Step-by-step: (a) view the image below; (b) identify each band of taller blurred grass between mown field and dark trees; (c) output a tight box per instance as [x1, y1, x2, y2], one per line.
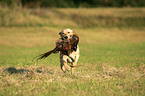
[0, 8, 145, 28]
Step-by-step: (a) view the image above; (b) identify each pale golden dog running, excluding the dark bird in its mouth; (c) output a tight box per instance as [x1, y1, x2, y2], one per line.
[59, 29, 80, 72]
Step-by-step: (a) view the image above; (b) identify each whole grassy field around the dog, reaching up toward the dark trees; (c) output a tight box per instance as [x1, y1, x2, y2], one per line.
[0, 8, 145, 96]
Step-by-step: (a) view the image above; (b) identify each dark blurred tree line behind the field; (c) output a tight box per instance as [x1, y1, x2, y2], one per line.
[0, 0, 145, 8]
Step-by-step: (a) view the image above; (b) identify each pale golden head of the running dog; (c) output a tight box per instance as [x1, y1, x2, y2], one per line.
[59, 28, 74, 40]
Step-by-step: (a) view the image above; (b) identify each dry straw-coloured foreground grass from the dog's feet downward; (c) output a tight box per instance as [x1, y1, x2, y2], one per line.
[0, 64, 144, 95]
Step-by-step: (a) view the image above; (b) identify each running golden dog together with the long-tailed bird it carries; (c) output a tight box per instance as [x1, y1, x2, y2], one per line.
[37, 28, 80, 73]
